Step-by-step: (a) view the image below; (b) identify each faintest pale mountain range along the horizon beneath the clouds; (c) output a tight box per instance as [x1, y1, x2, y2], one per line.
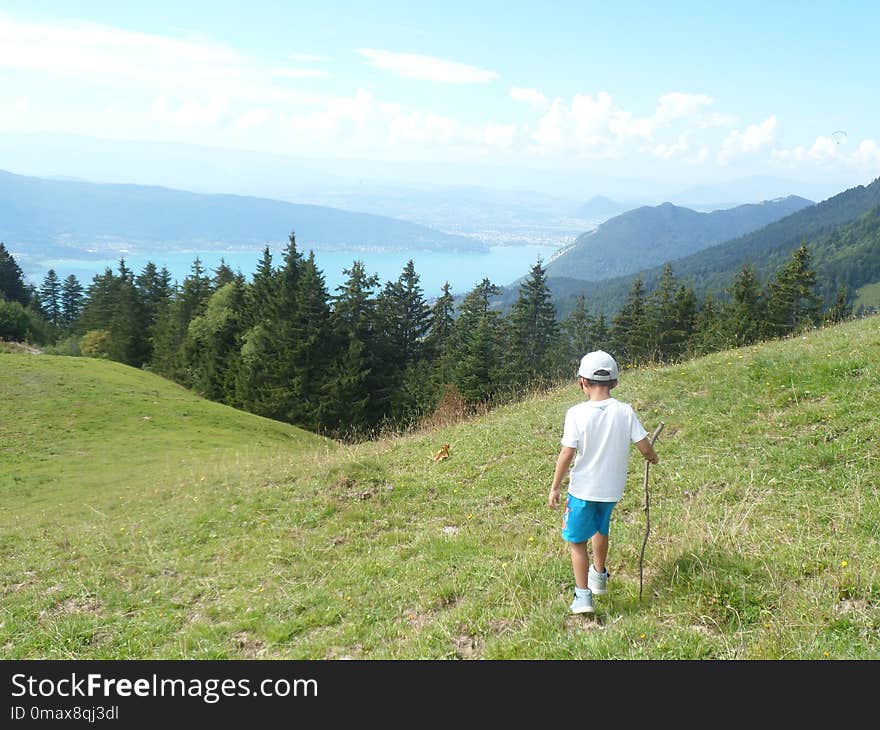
[0, 132, 858, 205]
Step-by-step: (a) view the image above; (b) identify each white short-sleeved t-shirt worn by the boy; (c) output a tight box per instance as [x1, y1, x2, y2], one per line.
[562, 398, 648, 502]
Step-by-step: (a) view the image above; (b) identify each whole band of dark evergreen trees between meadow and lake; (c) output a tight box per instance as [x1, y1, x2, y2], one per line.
[0, 234, 868, 439]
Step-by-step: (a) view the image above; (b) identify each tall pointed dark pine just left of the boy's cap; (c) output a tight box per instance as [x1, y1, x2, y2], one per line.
[510, 259, 559, 386]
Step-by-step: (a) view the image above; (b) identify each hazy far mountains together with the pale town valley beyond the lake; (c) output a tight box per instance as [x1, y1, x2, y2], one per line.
[0, 133, 861, 247]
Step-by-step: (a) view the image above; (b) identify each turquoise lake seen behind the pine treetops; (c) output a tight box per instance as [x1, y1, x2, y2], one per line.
[32, 245, 558, 299]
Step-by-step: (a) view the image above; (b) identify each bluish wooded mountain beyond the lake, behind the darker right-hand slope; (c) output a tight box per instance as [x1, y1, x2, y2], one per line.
[546, 195, 814, 281]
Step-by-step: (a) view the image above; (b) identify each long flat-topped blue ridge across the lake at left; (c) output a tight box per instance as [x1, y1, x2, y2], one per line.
[0, 171, 488, 255]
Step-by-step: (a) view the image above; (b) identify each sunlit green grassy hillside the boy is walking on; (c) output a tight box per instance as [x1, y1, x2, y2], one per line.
[0, 317, 880, 659]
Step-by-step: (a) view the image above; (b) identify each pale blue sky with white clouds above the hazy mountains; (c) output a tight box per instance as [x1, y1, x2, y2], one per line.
[0, 0, 880, 193]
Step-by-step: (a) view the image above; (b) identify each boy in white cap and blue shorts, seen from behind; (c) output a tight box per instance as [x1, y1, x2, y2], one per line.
[549, 350, 659, 613]
